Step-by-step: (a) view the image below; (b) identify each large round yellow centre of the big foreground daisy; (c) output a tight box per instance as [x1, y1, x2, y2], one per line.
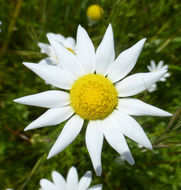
[70, 74, 118, 120]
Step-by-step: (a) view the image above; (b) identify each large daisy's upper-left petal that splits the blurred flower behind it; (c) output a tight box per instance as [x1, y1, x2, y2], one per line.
[47, 35, 83, 79]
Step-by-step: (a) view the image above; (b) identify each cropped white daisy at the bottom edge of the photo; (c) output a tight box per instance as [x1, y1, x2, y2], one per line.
[40, 167, 102, 190]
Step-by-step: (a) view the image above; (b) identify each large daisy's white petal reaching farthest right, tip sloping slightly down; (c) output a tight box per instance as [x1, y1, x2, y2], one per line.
[117, 98, 172, 116]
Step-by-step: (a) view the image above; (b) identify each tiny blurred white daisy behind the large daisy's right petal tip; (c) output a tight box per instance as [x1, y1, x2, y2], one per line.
[147, 60, 170, 92]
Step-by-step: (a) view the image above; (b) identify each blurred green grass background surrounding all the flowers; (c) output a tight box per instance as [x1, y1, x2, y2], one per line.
[0, 0, 181, 190]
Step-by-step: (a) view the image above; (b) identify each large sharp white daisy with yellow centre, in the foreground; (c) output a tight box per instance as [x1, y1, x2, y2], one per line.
[14, 24, 172, 175]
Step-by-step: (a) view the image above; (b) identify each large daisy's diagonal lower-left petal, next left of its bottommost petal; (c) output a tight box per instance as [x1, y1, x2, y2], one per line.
[47, 115, 84, 159]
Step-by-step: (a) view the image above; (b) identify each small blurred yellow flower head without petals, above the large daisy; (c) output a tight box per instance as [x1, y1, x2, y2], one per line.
[87, 4, 103, 21]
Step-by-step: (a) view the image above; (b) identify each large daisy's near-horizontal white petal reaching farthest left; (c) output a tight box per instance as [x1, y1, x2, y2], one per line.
[14, 90, 70, 108]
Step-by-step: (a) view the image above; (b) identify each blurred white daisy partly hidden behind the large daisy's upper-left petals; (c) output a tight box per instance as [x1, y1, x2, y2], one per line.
[38, 33, 75, 66]
